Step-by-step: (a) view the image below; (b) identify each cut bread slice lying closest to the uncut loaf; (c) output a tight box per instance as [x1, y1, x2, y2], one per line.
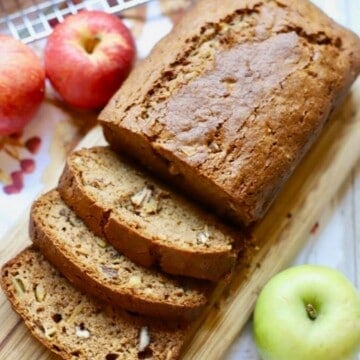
[59, 147, 241, 280]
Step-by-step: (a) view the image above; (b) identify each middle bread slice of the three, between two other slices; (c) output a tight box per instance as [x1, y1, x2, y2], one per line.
[30, 190, 210, 319]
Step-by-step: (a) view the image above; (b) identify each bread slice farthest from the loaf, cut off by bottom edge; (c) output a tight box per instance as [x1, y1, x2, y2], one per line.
[1, 248, 186, 360]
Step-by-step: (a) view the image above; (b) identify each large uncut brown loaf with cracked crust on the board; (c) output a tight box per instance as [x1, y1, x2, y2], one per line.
[100, 0, 360, 224]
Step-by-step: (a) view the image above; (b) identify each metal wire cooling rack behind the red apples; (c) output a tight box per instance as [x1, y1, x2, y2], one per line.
[0, 0, 150, 43]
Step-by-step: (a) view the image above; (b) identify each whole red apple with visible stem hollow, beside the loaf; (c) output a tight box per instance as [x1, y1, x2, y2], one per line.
[45, 11, 136, 109]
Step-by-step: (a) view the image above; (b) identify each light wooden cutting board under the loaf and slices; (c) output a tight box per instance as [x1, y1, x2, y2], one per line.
[0, 79, 360, 360]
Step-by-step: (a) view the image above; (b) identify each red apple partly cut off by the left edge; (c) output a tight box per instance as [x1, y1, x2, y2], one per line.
[0, 35, 45, 135]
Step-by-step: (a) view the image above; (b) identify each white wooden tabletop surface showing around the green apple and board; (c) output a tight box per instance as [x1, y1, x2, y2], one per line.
[225, 0, 360, 360]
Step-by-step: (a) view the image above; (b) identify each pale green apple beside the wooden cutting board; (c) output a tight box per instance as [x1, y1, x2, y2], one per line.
[253, 265, 360, 360]
